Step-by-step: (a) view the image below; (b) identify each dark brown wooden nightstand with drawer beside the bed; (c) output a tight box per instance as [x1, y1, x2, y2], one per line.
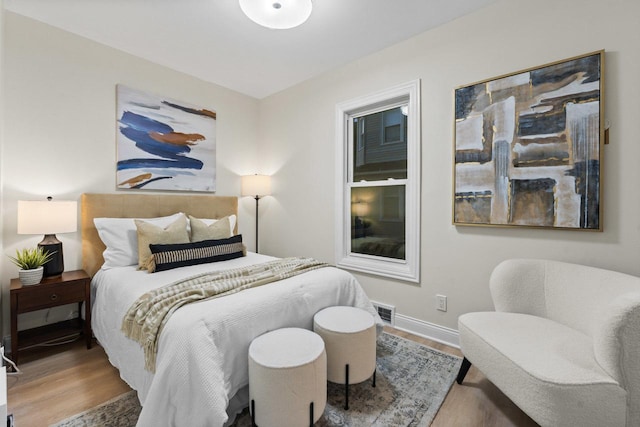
[10, 270, 91, 363]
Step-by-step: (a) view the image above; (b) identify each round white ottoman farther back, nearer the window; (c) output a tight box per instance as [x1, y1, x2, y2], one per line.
[313, 306, 376, 409]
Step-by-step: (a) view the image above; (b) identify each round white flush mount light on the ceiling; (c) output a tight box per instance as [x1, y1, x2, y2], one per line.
[240, 0, 312, 30]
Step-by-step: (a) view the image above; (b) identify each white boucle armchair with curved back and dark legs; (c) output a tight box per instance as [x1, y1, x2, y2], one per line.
[457, 259, 640, 427]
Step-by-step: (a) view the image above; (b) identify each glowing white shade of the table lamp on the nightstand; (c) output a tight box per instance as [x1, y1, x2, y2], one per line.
[18, 200, 78, 234]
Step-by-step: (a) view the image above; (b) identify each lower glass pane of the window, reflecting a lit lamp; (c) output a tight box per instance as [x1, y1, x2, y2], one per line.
[351, 185, 405, 259]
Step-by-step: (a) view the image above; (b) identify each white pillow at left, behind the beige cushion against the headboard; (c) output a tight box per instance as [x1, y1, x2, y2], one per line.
[93, 212, 184, 270]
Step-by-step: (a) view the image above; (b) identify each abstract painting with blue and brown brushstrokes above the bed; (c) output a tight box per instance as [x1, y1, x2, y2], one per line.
[116, 85, 216, 192]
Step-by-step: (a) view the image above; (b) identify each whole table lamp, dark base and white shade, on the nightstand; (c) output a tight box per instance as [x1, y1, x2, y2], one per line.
[18, 197, 78, 277]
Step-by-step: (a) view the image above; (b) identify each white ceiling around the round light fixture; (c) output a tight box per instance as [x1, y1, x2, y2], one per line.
[4, 0, 495, 99]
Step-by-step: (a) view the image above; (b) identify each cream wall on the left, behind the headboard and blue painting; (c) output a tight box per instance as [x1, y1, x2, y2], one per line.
[0, 11, 258, 335]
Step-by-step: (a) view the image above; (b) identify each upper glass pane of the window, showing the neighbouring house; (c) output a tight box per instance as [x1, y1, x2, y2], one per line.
[353, 106, 407, 182]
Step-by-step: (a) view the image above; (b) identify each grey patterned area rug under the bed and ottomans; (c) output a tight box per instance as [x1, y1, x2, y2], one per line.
[51, 333, 461, 427]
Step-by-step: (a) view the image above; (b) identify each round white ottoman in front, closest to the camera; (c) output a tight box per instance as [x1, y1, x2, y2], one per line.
[249, 328, 327, 427]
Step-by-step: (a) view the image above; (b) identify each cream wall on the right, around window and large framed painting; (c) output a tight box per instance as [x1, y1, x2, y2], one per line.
[259, 0, 640, 336]
